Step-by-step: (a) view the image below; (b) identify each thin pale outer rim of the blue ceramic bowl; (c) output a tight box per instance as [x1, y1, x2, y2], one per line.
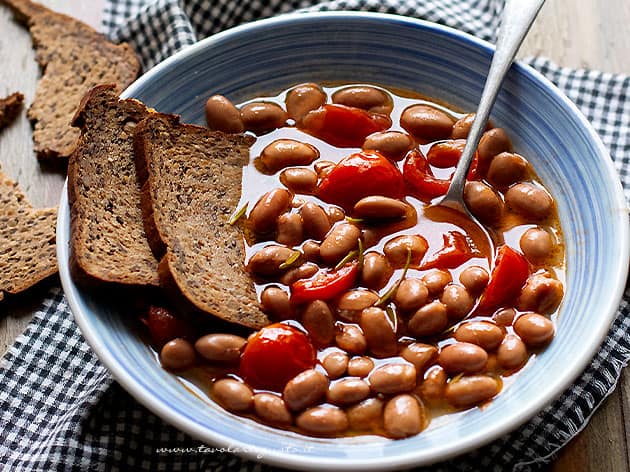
[57, 11, 630, 470]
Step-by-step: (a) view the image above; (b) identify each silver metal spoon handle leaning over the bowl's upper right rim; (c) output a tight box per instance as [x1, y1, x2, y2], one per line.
[444, 0, 545, 202]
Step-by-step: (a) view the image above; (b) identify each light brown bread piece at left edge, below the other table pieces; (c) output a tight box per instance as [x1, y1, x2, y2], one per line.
[0, 164, 57, 300]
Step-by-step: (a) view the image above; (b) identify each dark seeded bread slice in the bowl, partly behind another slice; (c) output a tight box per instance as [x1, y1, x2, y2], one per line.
[68, 85, 159, 286]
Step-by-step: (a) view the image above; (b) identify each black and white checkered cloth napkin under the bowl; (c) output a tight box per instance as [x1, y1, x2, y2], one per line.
[0, 0, 630, 472]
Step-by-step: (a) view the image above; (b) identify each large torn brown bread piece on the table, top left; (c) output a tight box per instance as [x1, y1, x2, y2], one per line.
[0, 0, 140, 158]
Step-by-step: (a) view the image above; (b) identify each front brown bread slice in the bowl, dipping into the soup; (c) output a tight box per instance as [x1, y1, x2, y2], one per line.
[134, 113, 269, 329]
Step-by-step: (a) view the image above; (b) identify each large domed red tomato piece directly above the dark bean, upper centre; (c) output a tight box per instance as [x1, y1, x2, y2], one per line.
[317, 151, 405, 211]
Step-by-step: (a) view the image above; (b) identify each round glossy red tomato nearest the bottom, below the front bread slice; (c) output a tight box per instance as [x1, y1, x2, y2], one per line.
[239, 323, 317, 392]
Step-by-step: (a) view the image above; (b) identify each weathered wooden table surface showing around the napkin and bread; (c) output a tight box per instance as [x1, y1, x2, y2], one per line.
[0, 0, 630, 472]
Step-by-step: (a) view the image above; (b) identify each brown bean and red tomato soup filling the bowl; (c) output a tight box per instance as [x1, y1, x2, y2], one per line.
[144, 82, 565, 439]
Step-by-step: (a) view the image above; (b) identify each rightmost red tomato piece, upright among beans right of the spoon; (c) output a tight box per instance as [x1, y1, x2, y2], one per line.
[475, 245, 529, 314]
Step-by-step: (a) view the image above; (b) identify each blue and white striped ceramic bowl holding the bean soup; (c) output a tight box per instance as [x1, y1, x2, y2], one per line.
[57, 13, 628, 471]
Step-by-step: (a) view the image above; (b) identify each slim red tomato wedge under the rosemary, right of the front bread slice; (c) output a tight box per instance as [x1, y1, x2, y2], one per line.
[291, 262, 359, 305]
